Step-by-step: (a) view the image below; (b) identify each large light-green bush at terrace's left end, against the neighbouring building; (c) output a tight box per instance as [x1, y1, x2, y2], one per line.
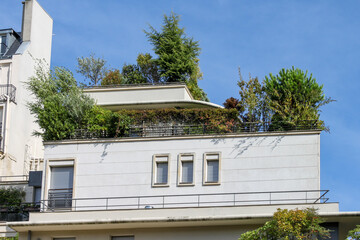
[26, 62, 94, 141]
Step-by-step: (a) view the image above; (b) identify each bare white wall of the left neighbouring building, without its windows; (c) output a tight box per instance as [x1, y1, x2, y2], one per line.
[0, 0, 53, 176]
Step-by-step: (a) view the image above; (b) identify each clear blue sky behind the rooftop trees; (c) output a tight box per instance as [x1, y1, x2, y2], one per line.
[0, 0, 360, 211]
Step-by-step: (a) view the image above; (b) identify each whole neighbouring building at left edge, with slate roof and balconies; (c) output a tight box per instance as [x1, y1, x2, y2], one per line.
[0, 0, 53, 236]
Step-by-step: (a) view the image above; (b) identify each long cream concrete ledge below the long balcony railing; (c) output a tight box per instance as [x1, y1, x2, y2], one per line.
[8, 203, 339, 232]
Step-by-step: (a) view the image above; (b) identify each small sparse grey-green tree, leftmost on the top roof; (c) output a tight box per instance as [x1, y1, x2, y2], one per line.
[76, 53, 106, 86]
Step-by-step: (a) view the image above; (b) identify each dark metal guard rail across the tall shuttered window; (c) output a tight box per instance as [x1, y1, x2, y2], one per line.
[48, 188, 73, 209]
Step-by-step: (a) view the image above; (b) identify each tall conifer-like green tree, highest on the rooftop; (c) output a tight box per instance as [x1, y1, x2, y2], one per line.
[145, 13, 208, 101]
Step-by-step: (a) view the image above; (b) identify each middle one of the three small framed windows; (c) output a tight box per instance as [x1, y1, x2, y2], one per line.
[178, 153, 195, 185]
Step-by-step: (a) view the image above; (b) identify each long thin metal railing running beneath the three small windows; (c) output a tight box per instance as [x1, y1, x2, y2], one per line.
[41, 190, 329, 211]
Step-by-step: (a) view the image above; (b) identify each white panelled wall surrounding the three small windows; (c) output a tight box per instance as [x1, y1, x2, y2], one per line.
[43, 132, 320, 206]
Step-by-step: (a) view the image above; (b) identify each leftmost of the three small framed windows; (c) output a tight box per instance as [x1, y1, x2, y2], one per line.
[153, 154, 169, 186]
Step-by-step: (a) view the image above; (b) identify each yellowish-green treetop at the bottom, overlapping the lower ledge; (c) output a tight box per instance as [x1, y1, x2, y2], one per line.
[239, 208, 330, 240]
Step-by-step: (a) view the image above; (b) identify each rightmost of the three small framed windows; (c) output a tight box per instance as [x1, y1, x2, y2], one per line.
[203, 153, 220, 185]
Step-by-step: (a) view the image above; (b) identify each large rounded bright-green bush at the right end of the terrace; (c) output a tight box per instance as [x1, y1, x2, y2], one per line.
[264, 67, 332, 128]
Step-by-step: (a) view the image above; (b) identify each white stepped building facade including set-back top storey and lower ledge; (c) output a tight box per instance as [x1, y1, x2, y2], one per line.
[9, 85, 360, 240]
